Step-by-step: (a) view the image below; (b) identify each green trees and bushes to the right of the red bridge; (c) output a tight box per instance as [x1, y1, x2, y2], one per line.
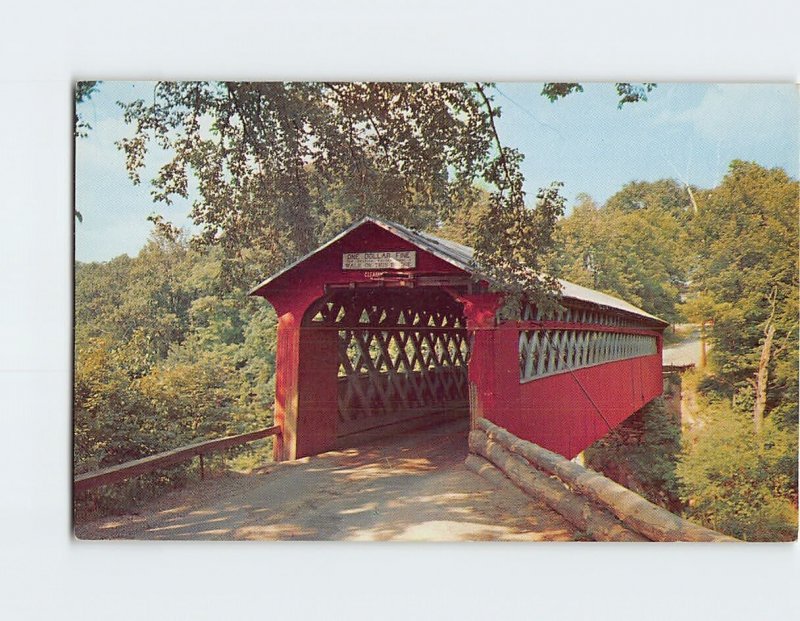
[564, 161, 798, 540]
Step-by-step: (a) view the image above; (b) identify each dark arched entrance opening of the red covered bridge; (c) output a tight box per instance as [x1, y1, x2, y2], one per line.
[300, 285, 470, 447]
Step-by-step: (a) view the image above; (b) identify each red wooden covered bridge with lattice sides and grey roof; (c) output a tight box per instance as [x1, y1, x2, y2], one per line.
[252, 218, 667, 460]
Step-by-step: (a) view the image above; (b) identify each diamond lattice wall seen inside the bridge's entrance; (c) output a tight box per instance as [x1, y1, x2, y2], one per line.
[306, 290, 469, 429]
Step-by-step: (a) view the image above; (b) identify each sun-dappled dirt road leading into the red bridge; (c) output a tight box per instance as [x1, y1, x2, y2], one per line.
[75, 420, 585, 541]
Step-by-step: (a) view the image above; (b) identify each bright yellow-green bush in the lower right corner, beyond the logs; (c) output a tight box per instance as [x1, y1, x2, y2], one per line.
[677, 401, 798, 541]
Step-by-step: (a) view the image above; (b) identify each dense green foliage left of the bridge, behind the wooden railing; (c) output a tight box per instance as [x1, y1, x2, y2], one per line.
[74, 219, 275, 511]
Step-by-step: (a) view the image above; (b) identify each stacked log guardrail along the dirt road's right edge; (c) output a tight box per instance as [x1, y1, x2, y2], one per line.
[466, 418, 738, 542]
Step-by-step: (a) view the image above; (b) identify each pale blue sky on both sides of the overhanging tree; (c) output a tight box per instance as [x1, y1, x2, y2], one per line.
[75, 82, 800, 261]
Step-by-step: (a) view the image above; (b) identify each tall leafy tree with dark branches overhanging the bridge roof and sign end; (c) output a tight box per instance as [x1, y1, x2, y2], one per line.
[108, 82, 653, 308]
